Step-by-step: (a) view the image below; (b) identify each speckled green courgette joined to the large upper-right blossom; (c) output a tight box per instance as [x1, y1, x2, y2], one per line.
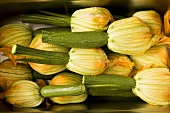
[42, 31, 108, 48]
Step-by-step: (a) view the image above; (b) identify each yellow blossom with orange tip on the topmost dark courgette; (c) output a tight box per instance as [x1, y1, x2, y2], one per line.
[70, 7, 114, 32]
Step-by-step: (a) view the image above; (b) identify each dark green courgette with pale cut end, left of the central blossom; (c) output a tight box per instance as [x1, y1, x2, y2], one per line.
[12, 44, 69, 65]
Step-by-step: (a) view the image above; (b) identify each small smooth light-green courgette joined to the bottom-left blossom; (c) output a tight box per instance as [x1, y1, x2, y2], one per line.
[40, 84, 86, 97]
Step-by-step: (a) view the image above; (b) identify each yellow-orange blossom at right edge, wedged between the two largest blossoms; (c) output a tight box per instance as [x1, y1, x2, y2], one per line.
[130, 45, 169, 69]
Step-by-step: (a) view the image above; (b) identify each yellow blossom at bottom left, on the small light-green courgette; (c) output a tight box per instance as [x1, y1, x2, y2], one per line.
[5, 80, 44, 107]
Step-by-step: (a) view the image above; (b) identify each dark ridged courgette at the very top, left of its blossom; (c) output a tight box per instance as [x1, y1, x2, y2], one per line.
[20, 11, 71, 27]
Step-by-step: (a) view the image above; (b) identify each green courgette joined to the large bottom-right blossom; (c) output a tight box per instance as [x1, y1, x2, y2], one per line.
[82, 74, 135, 89]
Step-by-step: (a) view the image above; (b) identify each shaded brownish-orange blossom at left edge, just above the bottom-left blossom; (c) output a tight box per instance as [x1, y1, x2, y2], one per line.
[0, 59, 32, 90]
